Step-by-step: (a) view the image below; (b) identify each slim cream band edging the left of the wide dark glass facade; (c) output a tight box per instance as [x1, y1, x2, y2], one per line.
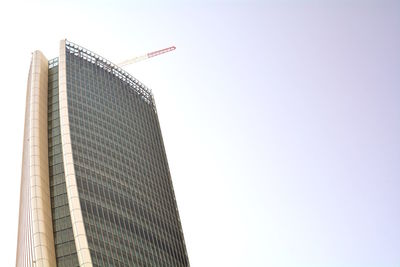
[58, 40, 93, 267]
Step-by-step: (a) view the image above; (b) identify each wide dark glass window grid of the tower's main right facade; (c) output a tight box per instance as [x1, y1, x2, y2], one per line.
[66, 49, 189, 266]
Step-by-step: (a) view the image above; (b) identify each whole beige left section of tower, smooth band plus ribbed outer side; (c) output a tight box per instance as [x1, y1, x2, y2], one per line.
[16, 51, 56, 266]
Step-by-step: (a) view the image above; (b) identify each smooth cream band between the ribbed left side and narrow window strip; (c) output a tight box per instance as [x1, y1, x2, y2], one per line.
[29, 51, 56, 266]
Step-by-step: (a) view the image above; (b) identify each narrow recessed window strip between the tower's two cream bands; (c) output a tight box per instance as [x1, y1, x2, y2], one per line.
[48, 59, 79, 267]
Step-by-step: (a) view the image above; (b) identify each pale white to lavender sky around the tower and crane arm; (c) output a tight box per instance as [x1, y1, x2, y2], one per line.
[0, 0, 400, 267]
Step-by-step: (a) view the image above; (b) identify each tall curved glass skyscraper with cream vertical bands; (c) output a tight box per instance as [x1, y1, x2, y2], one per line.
[16, 40, 189, 267]
